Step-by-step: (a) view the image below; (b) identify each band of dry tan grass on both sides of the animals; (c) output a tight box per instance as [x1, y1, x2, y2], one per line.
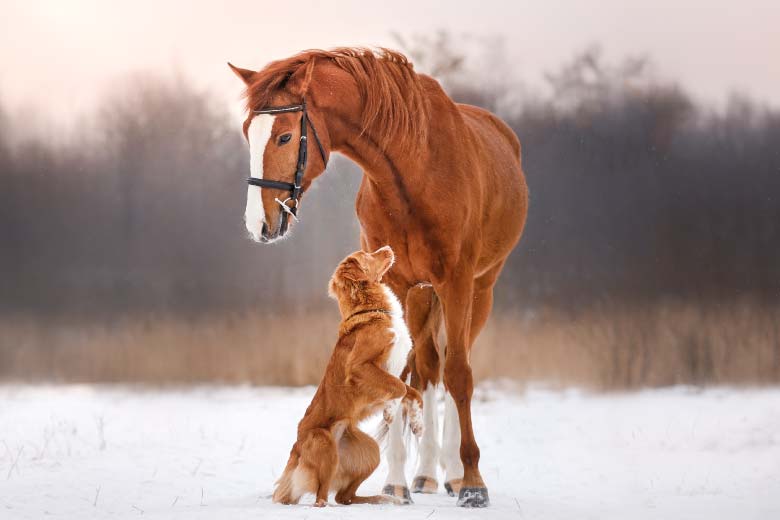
[0, 304, 780, 389]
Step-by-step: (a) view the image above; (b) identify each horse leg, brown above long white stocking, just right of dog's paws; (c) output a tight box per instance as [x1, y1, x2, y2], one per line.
[406, 285, 441, 493]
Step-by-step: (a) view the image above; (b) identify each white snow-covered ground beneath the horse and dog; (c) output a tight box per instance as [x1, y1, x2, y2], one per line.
[0, 385, 780, 520]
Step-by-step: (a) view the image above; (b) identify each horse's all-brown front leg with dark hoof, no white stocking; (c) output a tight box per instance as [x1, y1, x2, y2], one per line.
[436, 270, 490, 507]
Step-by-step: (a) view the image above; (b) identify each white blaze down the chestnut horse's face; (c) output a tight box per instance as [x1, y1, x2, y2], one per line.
[244, 114, 276, 242]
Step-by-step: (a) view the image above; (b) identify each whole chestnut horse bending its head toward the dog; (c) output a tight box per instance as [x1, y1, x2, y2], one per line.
[230, 48, 528, 507]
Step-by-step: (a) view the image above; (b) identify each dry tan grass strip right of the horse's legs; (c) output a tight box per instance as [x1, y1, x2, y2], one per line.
[472, 303, 780, 389]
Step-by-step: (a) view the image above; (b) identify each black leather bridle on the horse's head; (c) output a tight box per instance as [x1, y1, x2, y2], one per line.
[246, 99, 328, 235]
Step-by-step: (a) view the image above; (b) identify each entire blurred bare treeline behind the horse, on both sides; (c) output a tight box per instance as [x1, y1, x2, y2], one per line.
[0, 46, 780, 317]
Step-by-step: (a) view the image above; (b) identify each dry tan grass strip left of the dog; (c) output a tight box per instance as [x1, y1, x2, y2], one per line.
[0, 311, 339, 385]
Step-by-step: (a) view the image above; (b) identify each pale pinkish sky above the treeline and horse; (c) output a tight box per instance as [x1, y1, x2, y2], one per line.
[0, 0, 780, 126]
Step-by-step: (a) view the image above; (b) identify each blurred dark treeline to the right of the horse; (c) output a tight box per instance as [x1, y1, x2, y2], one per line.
[496, 51, 780, 306]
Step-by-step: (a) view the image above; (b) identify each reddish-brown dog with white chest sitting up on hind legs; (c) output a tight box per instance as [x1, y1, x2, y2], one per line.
[273, 246, 422, 507]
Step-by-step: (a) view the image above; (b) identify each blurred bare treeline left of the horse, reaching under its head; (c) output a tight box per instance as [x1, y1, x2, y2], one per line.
[0, 77, 360, 316]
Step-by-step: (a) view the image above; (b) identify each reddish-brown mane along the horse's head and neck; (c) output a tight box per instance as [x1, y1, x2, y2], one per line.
[245, 47, 429, 149]
